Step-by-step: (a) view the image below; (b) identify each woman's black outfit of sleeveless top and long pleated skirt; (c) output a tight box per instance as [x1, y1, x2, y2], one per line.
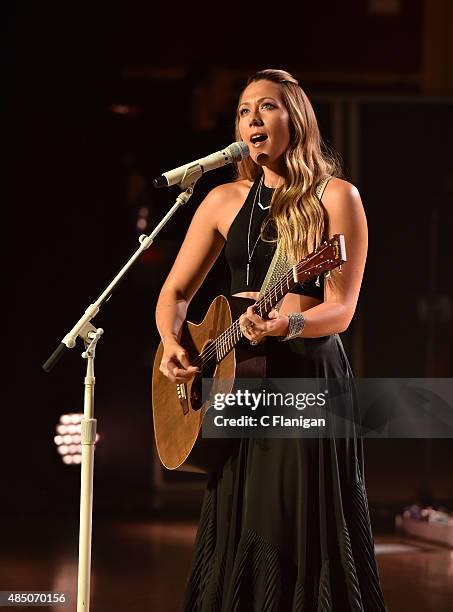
[184, 181, 386, 612]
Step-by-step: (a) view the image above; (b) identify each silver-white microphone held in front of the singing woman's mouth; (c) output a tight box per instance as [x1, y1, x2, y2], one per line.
[153, 141, 250, 188]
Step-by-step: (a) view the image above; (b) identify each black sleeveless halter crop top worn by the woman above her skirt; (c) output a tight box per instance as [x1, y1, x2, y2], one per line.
[225, 177, 324, 300]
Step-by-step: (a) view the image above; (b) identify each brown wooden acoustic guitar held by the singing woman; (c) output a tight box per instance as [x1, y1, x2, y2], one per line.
[152, 234, 346, 473]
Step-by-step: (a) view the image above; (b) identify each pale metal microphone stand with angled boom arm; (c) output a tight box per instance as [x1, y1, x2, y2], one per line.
[42, 164, 203, 612]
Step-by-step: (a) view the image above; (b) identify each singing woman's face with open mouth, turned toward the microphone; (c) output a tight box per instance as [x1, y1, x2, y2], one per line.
[238, 80, 290, 166]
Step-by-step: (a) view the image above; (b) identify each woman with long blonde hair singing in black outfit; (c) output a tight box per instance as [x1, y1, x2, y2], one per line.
[156, 70, 386, 612]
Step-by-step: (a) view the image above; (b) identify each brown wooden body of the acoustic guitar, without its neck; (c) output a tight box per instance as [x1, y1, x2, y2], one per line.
[152, 295, 265, 473]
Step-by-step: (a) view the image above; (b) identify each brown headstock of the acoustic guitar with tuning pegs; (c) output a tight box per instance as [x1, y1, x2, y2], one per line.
[293, 234, 346, 283]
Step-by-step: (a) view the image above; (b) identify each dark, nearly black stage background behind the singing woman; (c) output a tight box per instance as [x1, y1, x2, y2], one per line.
[6, 0, 453, 548]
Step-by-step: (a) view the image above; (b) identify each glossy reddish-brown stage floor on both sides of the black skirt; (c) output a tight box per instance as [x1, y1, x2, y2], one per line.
[0, 516, 453, 612]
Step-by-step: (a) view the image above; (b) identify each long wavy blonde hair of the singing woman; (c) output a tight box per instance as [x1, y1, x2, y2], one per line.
[235, 69, 341, 264]
